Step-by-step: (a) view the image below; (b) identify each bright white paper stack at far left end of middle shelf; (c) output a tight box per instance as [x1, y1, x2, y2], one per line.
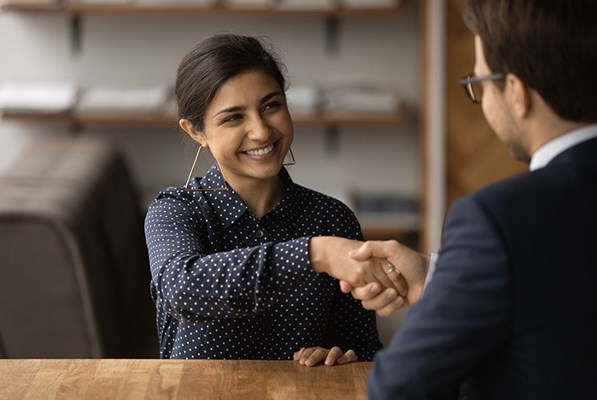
[0, 81, 77, 113]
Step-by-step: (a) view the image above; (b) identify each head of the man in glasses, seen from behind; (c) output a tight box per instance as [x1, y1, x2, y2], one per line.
[463, 0, 597, 161]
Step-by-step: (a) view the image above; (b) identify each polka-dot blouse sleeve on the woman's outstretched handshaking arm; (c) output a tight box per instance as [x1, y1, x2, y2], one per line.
[145, 189, 314, 322]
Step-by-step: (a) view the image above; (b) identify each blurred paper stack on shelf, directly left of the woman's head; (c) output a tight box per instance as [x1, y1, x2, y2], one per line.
[76, 85, 172, 114]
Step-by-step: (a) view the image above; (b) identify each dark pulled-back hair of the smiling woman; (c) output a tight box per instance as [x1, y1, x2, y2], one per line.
[175, 33, 286, 131]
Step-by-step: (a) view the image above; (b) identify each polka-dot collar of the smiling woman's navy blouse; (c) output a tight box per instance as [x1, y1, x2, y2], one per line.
[190, 164, 296, 228]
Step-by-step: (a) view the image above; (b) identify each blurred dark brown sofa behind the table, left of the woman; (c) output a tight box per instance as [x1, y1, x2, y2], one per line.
[0, 136, 158, 358]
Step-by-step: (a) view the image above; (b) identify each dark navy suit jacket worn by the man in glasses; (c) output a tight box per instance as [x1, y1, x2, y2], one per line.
[367, 139, 597, 400]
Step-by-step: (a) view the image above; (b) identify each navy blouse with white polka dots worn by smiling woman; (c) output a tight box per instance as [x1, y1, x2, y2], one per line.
[145, 167, 381, 360]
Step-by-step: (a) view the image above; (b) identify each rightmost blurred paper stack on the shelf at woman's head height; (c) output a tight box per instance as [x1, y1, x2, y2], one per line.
[322, 85, 401, 114]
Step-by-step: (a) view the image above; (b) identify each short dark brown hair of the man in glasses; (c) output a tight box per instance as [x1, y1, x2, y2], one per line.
[463, 0, 597, 122]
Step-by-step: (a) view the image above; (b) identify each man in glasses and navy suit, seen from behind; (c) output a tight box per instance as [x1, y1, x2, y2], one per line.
[343, 0, 597, 400]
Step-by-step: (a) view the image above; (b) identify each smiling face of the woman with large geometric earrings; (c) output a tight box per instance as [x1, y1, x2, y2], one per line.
[194, 70, 294, 187]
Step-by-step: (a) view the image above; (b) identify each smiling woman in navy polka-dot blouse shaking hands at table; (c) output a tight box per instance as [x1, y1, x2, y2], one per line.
[145, 34, 387, 366]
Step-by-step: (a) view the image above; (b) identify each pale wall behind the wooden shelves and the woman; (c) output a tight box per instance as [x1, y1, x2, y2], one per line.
[0, 1, 421, 341]
